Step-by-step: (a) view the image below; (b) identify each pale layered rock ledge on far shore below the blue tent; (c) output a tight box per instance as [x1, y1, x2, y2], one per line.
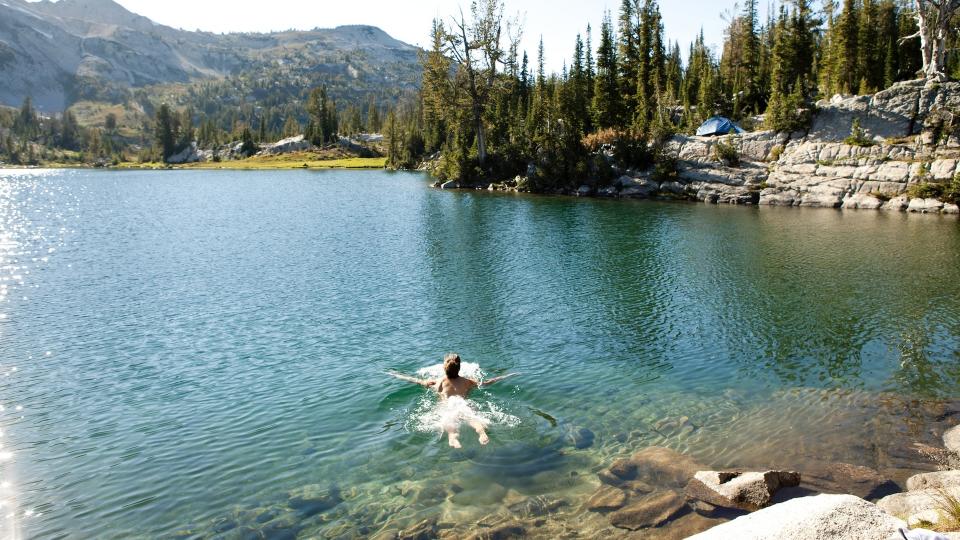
[437, 80, 960, 215]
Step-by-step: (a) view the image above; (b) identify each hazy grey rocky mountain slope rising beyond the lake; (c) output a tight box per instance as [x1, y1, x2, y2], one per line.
[0, 0, 419, 111]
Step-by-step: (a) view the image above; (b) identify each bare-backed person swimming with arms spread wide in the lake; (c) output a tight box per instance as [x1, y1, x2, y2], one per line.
[388, 353, 517, 448]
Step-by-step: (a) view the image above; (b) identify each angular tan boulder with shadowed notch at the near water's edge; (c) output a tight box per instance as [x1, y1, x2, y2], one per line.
[686, 471, 800, 512]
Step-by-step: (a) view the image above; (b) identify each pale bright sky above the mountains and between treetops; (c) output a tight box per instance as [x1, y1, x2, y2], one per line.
[52, 0, 767, 72]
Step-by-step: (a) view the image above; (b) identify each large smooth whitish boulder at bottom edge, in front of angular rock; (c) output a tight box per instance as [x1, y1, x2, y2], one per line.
[690, 495, 907, 540]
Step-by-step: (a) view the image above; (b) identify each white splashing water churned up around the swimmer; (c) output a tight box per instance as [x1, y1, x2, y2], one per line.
[407, 362, 520, 433]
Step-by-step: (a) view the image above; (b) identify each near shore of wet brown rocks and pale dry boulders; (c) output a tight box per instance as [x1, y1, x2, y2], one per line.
[572, 426, 960, 540]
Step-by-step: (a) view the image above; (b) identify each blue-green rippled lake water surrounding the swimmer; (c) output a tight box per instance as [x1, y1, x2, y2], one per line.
[0, 170, 960, 538]
